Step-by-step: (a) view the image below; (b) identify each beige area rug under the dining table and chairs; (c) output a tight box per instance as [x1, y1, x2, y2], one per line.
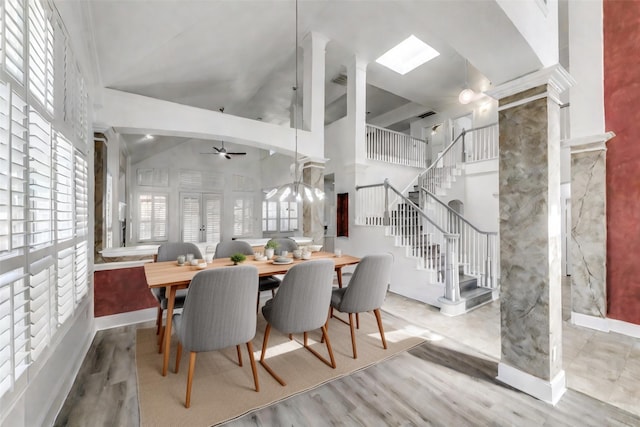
[136, 313, 424, 426]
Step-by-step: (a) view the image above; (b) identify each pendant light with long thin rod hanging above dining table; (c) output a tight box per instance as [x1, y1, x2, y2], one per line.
[266, 0, 324, 202]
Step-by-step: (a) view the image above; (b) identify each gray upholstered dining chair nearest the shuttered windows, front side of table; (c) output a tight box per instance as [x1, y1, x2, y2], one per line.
[173, 265, 260, 408]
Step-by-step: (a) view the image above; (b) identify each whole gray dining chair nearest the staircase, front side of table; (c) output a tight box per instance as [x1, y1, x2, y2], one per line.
[331, 254, 393, 359]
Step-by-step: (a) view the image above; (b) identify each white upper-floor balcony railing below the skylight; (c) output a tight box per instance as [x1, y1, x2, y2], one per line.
[366, 125, 430, 168]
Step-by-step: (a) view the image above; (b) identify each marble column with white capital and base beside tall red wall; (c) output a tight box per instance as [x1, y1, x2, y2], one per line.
[568, 133, 613, 331]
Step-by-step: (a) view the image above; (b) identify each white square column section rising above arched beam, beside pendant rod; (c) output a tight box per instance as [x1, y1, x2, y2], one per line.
[302, 33, 329, 144]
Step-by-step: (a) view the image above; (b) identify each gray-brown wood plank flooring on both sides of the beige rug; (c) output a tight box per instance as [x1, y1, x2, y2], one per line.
[55, 295, 640, 427]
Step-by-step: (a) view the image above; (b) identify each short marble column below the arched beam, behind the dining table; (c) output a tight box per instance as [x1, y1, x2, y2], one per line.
[302, 162, 324, 245]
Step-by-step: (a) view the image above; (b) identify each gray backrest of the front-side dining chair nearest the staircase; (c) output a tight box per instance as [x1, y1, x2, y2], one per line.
[338, 254, 393, 313]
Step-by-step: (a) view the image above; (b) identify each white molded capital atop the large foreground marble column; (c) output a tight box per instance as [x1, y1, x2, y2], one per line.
[486, 64, 575, 108]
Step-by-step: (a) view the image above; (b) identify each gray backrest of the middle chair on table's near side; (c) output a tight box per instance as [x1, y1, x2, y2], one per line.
[269, 259, 335, 334]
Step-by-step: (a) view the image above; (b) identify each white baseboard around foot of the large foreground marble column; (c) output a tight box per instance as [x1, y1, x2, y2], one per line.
[496, 363, 567, 405]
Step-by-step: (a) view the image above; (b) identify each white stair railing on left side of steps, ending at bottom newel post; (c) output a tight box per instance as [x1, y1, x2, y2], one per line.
[355, 180, 460, 302]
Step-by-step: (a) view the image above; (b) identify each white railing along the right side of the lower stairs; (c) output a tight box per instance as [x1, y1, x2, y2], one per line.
[420, 188, 498, 289]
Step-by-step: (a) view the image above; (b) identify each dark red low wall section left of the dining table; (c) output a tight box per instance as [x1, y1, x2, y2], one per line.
[93, 267, 158, 317]
